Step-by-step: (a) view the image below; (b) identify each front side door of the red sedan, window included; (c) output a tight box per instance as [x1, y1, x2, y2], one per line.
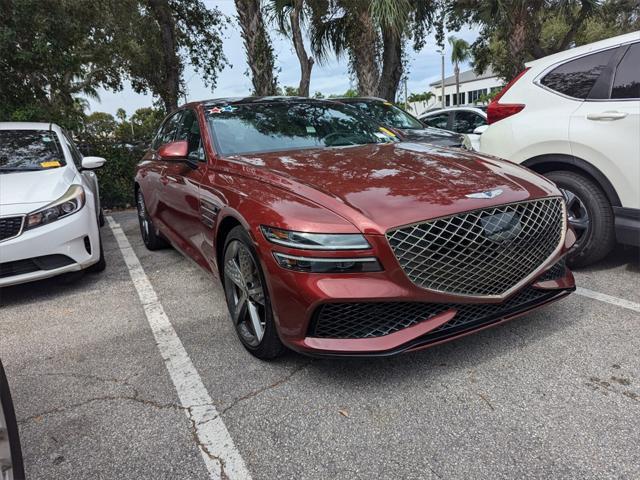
[161, 109, 207, 268]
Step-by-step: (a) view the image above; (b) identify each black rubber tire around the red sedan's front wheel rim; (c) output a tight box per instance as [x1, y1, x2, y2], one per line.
[222, 226, 285, 360]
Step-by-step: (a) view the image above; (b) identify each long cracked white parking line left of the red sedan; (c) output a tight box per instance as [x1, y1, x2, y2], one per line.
[107, 216, 251, 480]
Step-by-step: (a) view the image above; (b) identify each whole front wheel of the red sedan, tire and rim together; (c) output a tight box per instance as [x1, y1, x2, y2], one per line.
[222, 226, 284, 360]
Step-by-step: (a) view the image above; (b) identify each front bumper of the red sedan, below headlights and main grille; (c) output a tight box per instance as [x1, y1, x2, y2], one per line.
[257, 230, 575, 356]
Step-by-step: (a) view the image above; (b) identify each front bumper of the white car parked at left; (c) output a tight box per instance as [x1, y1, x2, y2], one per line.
[0, 204, 100, 287]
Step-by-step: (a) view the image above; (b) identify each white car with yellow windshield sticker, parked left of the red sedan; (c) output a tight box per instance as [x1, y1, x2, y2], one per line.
[0, 122, 105, 287]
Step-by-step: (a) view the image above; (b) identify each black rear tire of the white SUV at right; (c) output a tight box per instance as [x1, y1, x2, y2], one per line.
[545, 171, 616, 267]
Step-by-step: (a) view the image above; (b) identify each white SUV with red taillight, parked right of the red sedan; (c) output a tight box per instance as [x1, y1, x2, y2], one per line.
[480, 32, 640, 266]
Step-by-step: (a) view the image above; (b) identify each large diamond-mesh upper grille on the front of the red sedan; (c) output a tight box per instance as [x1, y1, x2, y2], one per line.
[387, 198, 565, 296]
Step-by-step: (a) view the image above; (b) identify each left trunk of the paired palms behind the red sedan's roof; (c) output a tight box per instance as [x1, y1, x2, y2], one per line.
[350, 8, 380, 97]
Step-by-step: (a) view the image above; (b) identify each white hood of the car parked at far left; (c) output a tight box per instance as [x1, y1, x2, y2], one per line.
[0, 167, 76, 205]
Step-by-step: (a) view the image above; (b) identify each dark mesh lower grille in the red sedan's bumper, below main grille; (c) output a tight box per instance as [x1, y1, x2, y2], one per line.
[309, 287, 558, 338]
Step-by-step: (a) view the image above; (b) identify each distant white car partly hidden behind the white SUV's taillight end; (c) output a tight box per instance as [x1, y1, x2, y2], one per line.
[420, 106, 487, 150]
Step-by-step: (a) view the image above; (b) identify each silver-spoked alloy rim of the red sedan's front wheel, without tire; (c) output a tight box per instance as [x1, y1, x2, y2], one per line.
[224, 240, 266, 347]
